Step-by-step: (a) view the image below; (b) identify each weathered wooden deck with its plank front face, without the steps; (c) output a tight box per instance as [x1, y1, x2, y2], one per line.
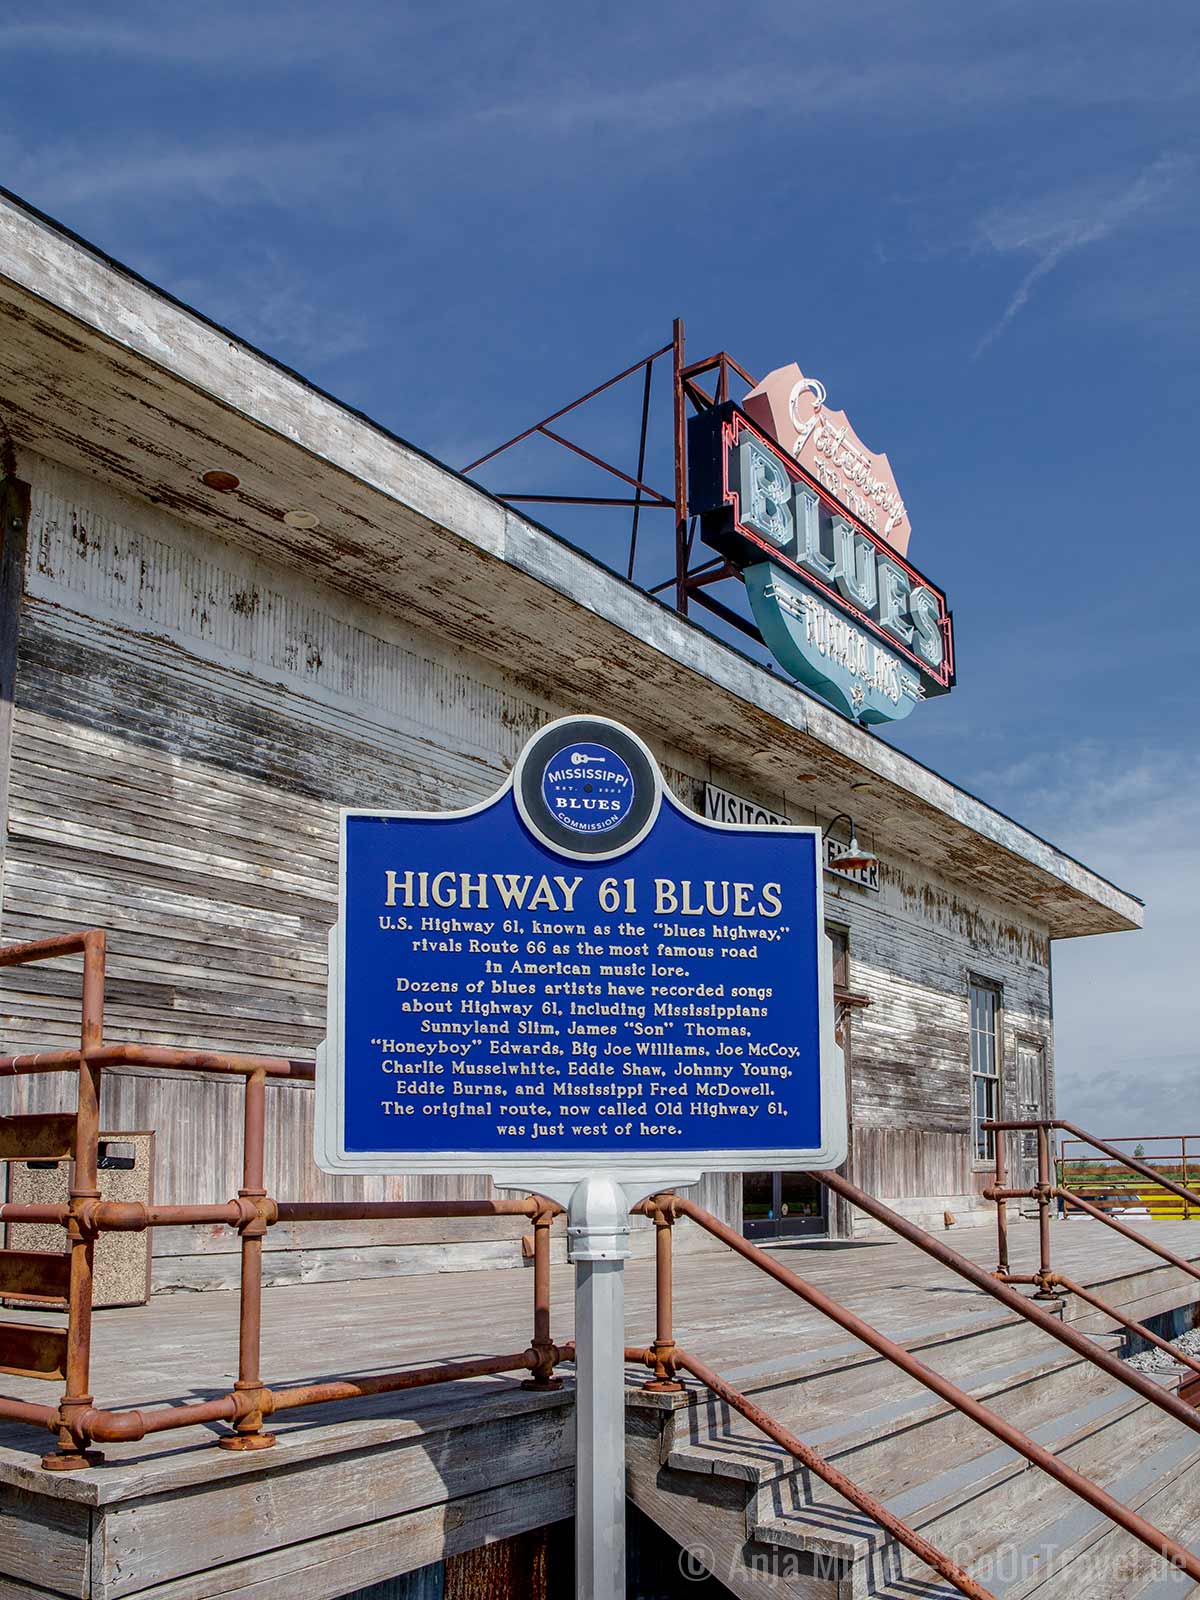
[0, 1221, 1200, 1600]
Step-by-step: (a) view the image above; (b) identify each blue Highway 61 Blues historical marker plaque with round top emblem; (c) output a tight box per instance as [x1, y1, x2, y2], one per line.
[317, 717, 846, 1186]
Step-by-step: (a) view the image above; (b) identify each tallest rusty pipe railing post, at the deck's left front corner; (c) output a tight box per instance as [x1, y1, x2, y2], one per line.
[42, 930, 104, 1472]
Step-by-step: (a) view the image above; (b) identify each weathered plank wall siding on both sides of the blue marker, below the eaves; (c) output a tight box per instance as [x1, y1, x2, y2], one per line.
[0, 462, 1050, 1286]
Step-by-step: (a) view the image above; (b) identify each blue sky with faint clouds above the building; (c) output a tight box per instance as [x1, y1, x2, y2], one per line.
[0, 0, 1200, 1133]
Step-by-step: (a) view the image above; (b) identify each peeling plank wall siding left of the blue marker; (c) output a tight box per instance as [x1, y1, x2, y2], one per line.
[0, 462, 739, 1286]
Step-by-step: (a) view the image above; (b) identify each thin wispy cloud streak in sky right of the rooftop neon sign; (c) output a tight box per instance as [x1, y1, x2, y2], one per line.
[974, 155, 1192, 357]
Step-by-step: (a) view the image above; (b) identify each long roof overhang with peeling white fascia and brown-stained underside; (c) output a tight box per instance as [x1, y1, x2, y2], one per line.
[0, 188, 1142, 938]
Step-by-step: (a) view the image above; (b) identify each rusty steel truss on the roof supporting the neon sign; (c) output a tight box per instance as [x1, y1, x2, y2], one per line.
[462, 317, 762, 643]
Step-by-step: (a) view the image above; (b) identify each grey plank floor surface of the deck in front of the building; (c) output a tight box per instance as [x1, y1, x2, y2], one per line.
[0, 1219, 1200, 1482]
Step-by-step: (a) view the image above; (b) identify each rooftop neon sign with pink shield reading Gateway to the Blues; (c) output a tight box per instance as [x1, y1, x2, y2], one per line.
[688, 366, 954, 723]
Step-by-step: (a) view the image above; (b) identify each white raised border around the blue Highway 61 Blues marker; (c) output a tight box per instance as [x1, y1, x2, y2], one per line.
[314, 714, 848, 1192]
